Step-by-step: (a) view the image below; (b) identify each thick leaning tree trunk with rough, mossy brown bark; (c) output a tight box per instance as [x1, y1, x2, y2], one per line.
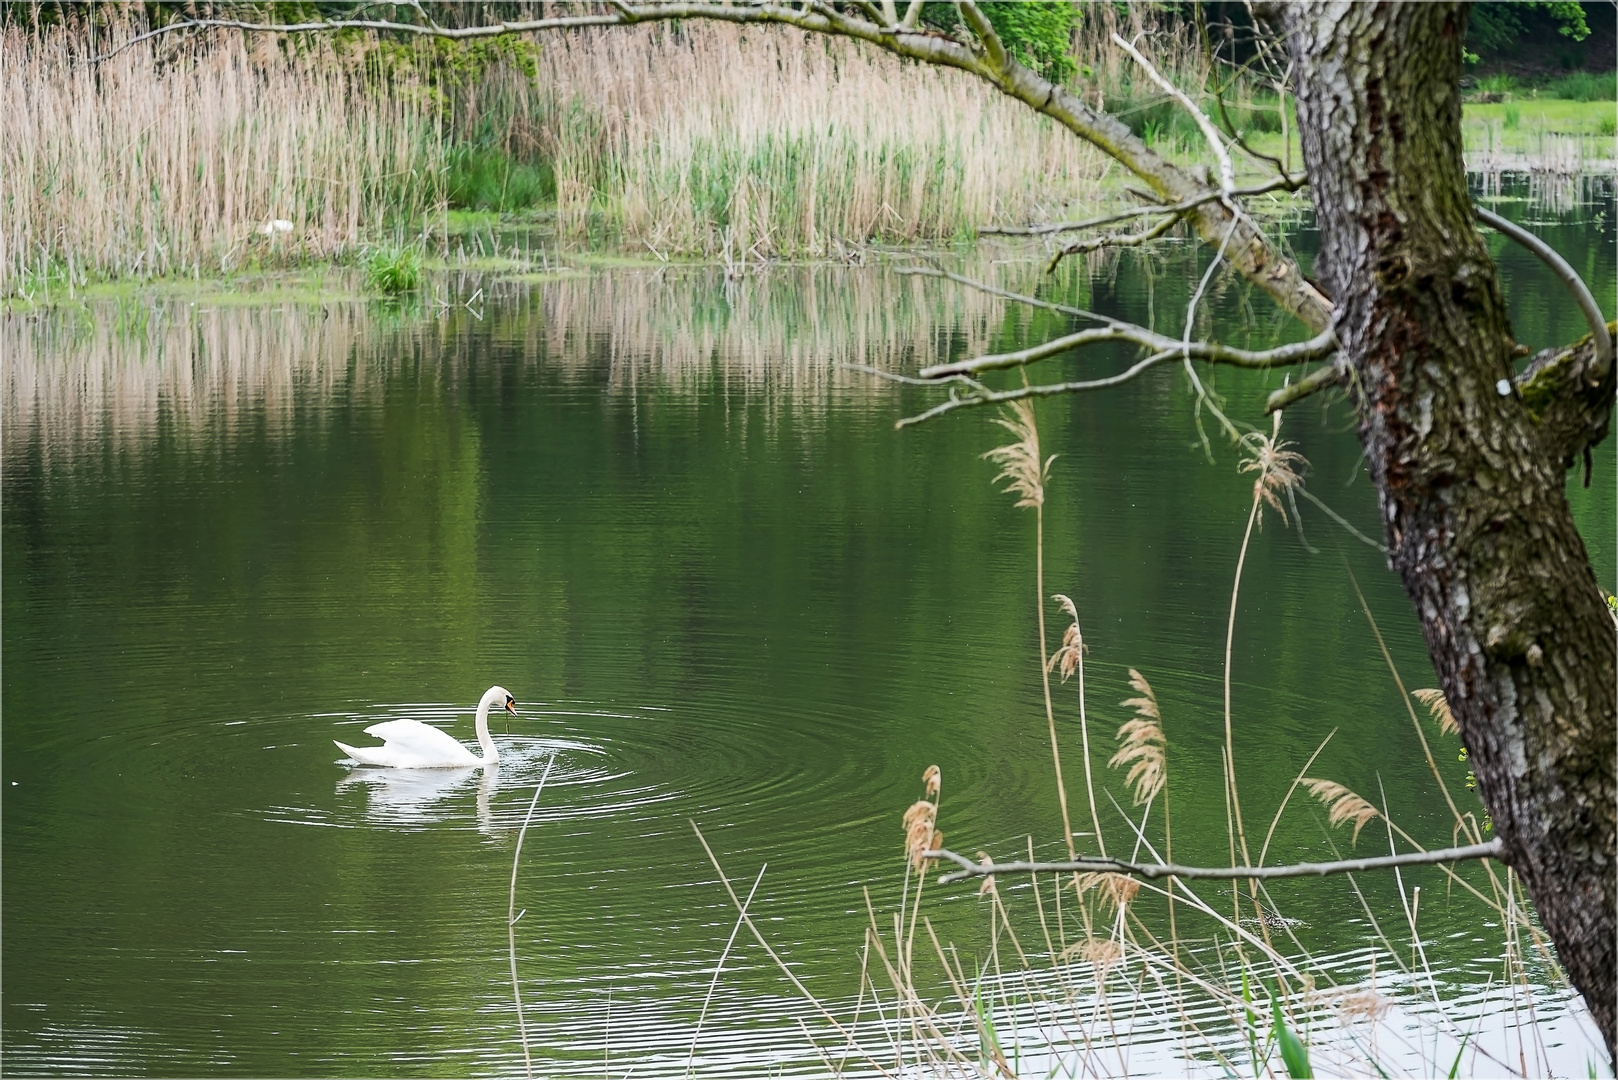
[1281, 3, 1618, 1056]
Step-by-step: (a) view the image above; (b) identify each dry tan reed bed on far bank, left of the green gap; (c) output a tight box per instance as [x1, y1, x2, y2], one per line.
[0, 24, 442, 296]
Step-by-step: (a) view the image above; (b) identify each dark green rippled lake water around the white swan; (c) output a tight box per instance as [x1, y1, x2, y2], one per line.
[0, 185, 1618, 1077]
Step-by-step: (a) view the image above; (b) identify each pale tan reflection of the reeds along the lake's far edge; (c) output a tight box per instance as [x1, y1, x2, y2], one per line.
[0, 267, 1005, 458]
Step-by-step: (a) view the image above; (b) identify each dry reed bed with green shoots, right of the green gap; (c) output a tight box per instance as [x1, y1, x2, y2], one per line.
[536, 23, 1105, 262]
